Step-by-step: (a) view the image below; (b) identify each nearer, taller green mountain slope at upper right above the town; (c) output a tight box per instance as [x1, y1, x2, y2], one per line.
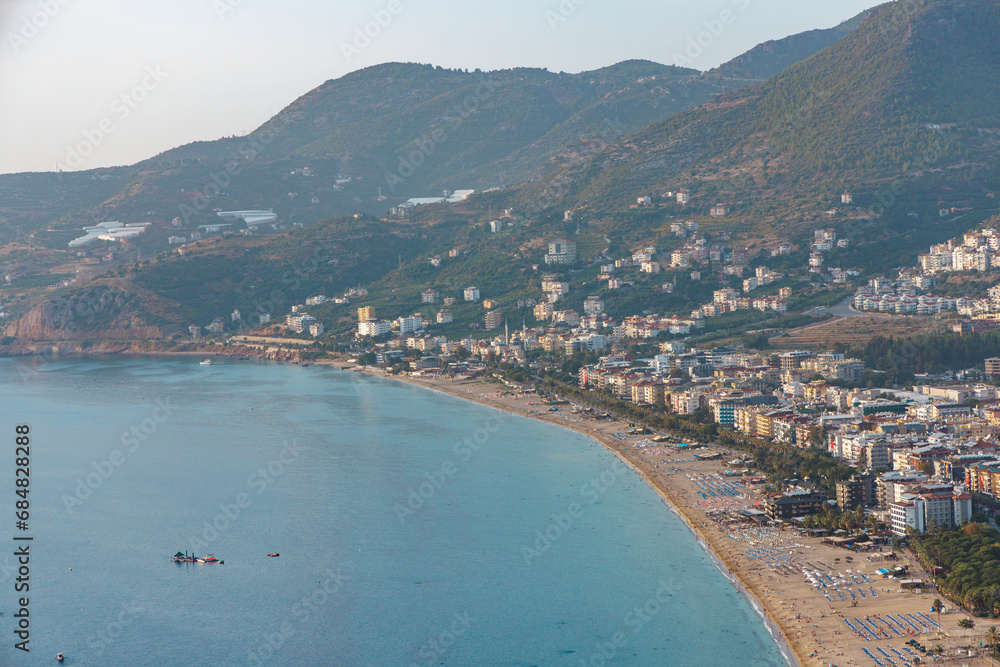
[540, 0, 1000, 222]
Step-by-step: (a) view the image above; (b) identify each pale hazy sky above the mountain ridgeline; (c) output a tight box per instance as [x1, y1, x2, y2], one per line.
[0, 0, 880, 173]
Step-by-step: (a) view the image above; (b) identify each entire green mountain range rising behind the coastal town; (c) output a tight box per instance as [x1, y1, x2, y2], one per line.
[0, 0, 1000, 338]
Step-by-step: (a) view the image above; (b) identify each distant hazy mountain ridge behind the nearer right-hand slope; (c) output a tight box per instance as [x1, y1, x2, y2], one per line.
[0, 7, 872, 246]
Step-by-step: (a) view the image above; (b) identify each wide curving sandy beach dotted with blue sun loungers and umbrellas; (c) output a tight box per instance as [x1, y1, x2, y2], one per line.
[336, 364, 991, 667]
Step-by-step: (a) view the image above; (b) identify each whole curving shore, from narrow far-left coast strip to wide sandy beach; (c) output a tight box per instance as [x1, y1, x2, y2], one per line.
[7, 347, 986, 667]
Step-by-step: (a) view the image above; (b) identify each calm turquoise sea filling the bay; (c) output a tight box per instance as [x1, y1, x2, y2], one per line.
[0, 359, 784, 667]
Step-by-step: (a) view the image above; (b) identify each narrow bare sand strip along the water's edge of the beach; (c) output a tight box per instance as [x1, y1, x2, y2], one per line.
[340, 362, 806, 667]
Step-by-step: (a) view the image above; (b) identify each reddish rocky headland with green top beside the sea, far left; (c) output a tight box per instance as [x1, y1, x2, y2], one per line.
[4, 286, 167, 341]
